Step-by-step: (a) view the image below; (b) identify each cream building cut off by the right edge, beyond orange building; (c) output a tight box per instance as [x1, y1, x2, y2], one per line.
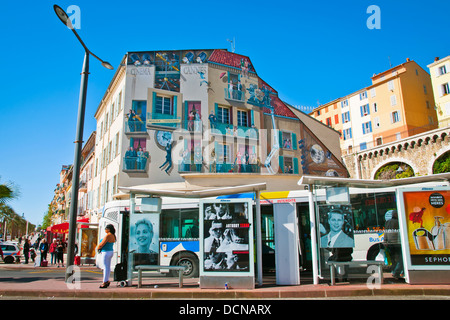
[428, 56, 450, 128]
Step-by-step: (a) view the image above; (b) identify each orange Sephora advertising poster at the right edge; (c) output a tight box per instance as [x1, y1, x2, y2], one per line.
[400, 189, 450, 269]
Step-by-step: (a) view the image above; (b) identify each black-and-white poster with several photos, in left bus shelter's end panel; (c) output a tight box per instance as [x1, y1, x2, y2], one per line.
[200, 199, 253, 275]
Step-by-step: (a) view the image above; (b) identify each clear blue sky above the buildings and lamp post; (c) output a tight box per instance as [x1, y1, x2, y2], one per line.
[0, 0, 450, 224]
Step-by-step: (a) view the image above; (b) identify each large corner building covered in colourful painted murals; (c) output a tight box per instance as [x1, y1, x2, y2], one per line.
[88, 49, 348, 221]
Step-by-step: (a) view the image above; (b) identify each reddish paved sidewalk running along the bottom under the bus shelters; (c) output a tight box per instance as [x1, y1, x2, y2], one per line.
[0, 263, 450, 300]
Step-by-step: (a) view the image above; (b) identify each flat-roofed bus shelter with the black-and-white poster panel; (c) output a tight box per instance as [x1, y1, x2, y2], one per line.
[119, 183, 266, 288]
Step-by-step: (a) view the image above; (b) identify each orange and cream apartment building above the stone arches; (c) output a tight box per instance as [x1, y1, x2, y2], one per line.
[310, 59, 438, 154]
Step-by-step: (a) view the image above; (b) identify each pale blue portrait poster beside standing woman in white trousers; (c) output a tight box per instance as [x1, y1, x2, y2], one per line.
[129, 213, 159, 269]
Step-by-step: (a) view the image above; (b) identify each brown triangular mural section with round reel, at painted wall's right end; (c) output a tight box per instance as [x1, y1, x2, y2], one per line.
[298, 126, 348, 177]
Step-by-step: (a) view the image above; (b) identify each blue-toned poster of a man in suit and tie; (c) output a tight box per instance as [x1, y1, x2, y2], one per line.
[319, 204, 355, 249]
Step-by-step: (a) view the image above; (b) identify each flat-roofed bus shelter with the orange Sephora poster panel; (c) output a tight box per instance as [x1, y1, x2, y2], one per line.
[298, 173, 450, 284]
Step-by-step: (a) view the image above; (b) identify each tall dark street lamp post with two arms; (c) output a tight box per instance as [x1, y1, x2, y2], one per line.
[53, 4, 114, 282]
